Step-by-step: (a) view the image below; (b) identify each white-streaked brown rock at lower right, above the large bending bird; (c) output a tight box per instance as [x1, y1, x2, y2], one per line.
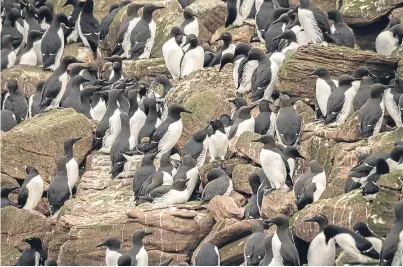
[291, 188, 399, 242]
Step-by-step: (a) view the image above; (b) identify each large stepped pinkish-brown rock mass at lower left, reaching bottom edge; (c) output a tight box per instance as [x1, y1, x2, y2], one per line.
[49, 153, 214, 265]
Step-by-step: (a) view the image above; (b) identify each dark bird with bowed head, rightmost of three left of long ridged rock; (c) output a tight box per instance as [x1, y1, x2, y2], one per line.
[246, 48, 272, 101]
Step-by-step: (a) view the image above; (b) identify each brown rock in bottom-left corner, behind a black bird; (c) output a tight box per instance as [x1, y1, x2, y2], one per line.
[1, 206, 52, 258]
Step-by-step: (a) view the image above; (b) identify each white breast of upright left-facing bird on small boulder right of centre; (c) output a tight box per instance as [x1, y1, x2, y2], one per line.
[260, 149, 287, 189]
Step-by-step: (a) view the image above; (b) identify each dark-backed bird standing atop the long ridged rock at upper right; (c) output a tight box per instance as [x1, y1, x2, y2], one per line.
[327, 8, 355, 48]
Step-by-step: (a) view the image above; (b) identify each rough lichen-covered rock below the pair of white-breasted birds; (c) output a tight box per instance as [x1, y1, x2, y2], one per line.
[166, 65, 235, 147]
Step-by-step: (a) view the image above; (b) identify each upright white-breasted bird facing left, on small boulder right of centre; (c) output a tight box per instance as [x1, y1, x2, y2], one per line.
[252, 134, 292, 191]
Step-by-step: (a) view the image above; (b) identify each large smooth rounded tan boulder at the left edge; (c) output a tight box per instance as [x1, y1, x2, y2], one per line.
[1, 108, 92, 182]
